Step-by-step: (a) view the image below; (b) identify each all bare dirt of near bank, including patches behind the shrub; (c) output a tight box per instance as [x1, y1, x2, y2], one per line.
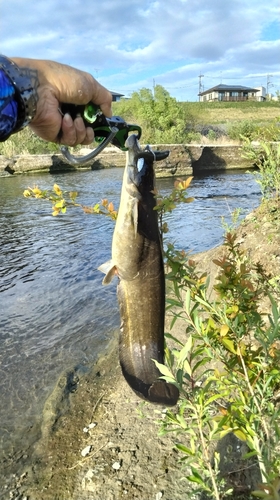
[7, 198, 280, 500]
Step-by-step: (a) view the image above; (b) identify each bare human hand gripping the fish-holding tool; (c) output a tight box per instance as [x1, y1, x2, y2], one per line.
[11, 57, 112, 146]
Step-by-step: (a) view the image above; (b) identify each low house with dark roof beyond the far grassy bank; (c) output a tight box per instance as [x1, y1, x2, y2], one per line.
[198, 83, 265, 102]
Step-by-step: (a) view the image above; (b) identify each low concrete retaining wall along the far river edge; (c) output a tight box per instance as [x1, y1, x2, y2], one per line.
[0, 144, 252, 177]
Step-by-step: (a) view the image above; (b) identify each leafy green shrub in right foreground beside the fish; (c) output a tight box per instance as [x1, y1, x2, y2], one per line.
[151, 150, 280, 500]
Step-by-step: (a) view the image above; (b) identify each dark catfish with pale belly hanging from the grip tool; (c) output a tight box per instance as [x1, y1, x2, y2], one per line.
[100, 135, 179, 406]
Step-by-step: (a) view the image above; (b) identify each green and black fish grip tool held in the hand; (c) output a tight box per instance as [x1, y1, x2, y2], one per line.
[60, 103, 142, 165]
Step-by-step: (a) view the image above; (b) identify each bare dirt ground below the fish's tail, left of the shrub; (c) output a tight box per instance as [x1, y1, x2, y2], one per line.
[6, 341, 190, 500]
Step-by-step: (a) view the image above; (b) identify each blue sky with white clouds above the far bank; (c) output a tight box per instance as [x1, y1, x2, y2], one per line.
[0, 0, 280, 101]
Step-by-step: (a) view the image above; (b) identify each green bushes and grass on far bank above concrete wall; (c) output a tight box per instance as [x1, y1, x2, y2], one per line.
[0, 85, 280, 157]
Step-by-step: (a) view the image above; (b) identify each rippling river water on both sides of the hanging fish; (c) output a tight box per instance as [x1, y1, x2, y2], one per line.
[0, 168, 260, 487]
